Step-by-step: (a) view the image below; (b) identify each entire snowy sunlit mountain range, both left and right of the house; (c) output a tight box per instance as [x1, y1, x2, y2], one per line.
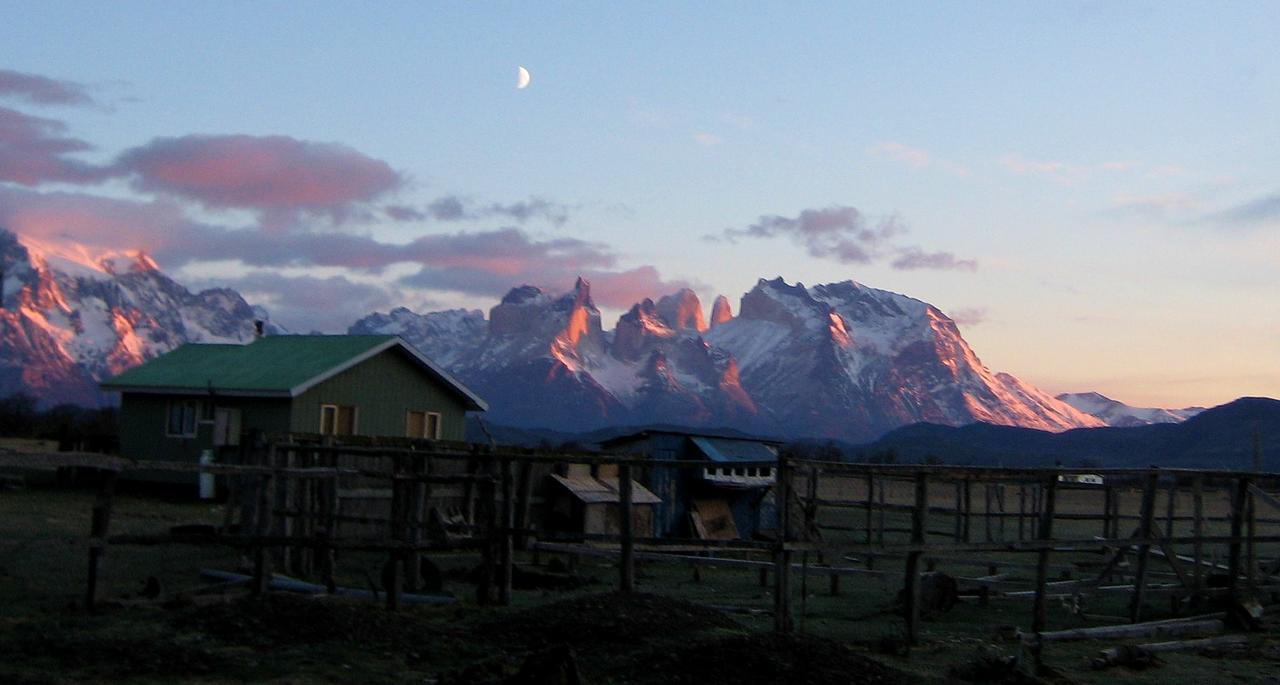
[0, 230, 1213, 442]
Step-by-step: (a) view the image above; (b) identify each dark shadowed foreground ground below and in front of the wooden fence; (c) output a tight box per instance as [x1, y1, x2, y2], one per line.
[0, 490, 1280, 685]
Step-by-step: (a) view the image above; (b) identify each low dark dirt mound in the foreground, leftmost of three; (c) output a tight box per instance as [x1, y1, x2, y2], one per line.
[173, 594, 445, 647]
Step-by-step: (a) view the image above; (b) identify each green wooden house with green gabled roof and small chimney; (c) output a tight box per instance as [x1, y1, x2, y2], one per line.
[101, 335, 488, 489]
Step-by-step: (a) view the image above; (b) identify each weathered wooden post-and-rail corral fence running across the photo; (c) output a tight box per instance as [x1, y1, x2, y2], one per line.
[0, 437, 1280, 656]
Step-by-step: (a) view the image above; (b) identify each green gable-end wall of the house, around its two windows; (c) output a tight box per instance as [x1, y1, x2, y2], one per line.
[289, 348, 466, 440]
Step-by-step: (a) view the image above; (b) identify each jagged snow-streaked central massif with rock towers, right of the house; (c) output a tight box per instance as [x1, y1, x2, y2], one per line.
[349, 278, 1105, 440]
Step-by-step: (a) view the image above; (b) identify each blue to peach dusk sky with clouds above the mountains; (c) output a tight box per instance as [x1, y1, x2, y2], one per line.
[0, 0, 1280, 407]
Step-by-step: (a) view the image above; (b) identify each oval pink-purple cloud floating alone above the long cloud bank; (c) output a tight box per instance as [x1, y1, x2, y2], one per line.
[114, 136, 403, 216]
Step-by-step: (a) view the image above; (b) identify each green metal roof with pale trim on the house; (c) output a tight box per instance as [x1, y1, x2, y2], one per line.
[101, 335, 488, 410]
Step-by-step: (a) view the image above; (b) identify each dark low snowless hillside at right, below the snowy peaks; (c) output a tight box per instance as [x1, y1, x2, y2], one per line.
[855, 397, 1280, 471]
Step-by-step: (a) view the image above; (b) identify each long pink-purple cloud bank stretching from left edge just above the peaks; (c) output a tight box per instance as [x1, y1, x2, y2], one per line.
[0, 187, 689, 314]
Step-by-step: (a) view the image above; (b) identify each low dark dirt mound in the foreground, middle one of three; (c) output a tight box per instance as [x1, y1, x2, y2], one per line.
[483, 593, 741, 647]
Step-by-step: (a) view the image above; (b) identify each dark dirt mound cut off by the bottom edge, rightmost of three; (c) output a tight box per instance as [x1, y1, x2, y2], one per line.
[635, 634, 915, 685]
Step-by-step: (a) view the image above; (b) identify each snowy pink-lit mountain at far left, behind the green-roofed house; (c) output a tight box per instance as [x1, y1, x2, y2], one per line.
[0, 230, 279, 407]
